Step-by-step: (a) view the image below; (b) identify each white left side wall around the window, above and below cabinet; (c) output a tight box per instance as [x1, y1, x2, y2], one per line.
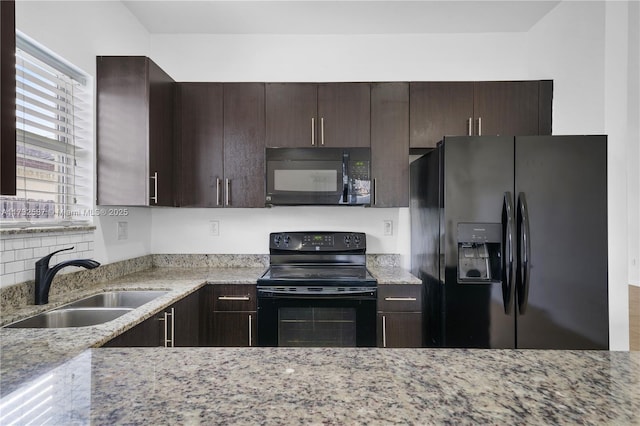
[16, 1, 151, 263]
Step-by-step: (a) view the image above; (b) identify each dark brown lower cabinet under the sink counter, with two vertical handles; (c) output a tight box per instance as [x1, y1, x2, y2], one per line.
[103, 290, 202, 347]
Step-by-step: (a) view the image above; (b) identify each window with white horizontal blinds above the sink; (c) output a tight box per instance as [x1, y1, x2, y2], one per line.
[0, 33, 93, 226]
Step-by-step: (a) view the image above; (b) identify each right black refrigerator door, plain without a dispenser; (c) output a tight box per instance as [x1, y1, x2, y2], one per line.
[515, 136, 609, 349]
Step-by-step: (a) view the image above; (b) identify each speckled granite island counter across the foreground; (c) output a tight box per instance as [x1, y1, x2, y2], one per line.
[2, 348, 640, 425]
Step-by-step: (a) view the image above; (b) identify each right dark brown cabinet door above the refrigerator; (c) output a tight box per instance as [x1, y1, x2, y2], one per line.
[474, 81, 539, 136]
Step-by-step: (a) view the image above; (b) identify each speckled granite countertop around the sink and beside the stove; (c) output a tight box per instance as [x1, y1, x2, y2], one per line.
[0, 266, 420, 397]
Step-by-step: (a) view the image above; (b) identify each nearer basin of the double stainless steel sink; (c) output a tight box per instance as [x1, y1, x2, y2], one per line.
[6, 308, 133, 328]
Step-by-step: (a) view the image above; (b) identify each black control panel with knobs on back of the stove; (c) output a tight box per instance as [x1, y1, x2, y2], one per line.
[269, 231, 367, 252]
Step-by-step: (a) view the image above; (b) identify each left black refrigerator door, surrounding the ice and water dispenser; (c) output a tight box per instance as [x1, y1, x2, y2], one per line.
[441, 136, 515, 348]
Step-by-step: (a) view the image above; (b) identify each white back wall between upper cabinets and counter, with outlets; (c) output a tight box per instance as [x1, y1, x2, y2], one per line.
[151, 207, 409, 256]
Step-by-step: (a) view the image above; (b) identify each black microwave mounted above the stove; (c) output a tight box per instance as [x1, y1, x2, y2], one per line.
[265, 148, 371, 206]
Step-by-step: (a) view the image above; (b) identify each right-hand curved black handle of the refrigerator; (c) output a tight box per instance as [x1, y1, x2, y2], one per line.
[516, 192, 531, 314]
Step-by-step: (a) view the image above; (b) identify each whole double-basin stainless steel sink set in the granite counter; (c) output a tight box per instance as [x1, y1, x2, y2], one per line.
[5, 290, 168, 328]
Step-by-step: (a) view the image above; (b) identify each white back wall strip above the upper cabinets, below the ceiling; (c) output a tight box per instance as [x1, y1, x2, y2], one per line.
[151, 33, 531, 82]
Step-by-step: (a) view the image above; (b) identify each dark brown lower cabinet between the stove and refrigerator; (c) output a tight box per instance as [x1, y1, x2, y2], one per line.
[377, 284, 423, 348]
